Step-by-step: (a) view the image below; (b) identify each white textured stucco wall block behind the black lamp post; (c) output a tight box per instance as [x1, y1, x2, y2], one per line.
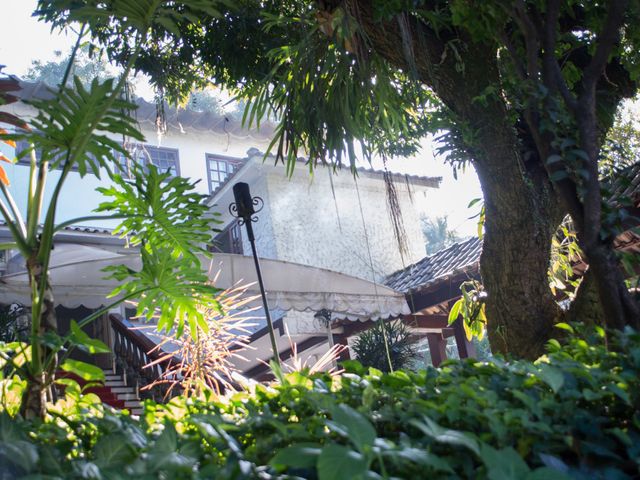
[213, 156, 435, 281]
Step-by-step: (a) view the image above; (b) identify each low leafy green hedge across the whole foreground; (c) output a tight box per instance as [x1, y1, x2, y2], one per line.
[0, 332, 640, 480]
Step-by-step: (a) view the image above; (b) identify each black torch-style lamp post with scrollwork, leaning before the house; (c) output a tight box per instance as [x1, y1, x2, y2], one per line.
[229, 182, 280, 365]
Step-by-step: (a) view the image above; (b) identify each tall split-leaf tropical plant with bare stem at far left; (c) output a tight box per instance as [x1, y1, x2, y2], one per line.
[0, 0, 229, 417]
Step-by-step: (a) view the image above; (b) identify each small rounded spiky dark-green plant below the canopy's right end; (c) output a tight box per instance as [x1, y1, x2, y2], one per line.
[351, 320, 420, 372]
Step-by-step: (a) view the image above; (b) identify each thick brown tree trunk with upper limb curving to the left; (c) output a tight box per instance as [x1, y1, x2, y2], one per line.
[360, 8, 563, 358]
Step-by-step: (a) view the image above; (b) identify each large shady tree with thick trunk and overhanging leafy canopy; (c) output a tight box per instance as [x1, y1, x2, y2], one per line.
[76, 0, 640, 358]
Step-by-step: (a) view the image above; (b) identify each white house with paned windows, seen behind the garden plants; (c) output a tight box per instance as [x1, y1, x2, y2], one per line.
[0, 79, 440, 382]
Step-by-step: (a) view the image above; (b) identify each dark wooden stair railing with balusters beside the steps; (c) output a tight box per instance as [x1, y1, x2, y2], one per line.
[109, 314, 180, 402]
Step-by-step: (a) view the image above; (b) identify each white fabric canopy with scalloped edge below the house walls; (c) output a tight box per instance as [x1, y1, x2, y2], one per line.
[0, 244, 409, 320]
